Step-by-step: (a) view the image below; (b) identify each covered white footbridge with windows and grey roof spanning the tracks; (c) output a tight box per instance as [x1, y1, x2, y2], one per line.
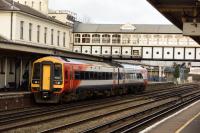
[73, 23, 200, 65]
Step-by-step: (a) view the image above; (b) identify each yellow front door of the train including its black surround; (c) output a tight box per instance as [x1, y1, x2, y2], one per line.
[41, 63, 53, 91]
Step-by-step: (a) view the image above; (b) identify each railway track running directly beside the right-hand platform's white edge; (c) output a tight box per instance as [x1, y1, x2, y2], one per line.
[81, 93, 200, 133]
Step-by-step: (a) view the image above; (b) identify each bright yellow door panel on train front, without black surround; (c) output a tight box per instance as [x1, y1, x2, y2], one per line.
[42, 65, 51, 91]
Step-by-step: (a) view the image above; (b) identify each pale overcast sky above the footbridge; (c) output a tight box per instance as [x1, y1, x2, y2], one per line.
[49, 0, 170, 24]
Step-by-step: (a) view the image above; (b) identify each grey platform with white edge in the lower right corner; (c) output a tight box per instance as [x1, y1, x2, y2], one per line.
[140, 100, 200, 133]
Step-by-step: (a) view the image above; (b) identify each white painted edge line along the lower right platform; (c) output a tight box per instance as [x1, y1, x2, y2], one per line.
[140, 100, 200, 133]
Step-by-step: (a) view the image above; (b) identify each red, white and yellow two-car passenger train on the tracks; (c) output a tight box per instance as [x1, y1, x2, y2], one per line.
[31, 56, 148, 103]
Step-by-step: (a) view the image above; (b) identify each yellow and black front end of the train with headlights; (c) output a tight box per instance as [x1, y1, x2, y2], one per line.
[31, 61, 64, 103]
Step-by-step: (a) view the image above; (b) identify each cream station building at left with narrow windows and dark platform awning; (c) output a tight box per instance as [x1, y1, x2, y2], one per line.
[0, 0, 73, 89]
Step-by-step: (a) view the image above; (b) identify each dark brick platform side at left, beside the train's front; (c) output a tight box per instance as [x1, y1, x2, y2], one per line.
[0, 91, 33, 111]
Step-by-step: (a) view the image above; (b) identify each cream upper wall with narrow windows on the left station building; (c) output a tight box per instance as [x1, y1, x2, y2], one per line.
[13, 13, 72, 50]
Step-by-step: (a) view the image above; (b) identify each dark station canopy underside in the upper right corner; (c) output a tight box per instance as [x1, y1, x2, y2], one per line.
[147, 0, 200, 44]
